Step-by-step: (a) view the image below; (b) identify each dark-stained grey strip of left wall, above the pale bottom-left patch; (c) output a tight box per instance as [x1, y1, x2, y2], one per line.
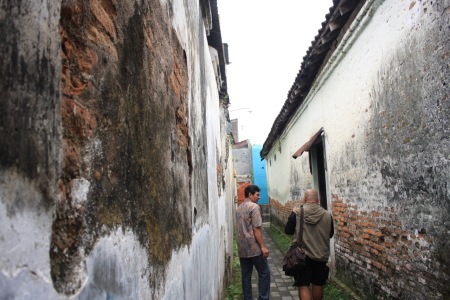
[0, 1, 61, 212]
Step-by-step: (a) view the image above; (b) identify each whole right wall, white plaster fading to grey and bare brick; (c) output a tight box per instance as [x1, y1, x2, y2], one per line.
[267, 0, 450, 299]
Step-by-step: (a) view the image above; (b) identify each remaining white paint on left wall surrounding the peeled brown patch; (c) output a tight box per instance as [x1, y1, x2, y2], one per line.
[0, 0, 236, 300]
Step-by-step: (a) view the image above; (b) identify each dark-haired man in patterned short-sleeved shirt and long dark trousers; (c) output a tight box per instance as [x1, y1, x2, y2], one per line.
[236, 185, 270, 300]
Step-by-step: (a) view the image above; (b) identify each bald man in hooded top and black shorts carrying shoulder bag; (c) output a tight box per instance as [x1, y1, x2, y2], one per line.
[284, 189, 334, 300]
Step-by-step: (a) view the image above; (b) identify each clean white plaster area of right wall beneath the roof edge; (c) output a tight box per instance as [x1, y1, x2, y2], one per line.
[266, 0, 442, 209]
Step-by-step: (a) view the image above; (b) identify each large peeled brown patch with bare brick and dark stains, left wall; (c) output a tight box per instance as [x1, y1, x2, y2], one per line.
[50, 0, 194, 295]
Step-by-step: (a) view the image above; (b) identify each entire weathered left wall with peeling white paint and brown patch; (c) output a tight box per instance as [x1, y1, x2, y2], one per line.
[0, 0, 234, 299]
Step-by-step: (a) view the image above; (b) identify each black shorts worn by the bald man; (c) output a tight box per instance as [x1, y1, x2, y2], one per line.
[294, 257, 330, 286]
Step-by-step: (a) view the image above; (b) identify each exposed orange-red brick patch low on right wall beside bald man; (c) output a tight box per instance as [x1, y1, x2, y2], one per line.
[332, 195, 443, 299]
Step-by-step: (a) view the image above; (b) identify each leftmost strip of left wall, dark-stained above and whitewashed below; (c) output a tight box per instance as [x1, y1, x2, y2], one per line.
[0, 0, 62, 299]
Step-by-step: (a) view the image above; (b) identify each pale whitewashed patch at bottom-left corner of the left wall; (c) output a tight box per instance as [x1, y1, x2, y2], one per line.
[0, 170, 63, 300]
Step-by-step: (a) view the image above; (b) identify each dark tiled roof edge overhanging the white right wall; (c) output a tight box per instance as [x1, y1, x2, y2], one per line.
[260, 0, 366, 159]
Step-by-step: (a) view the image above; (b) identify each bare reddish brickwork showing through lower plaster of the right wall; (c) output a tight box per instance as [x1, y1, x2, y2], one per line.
[332, 195, 436, 298]
